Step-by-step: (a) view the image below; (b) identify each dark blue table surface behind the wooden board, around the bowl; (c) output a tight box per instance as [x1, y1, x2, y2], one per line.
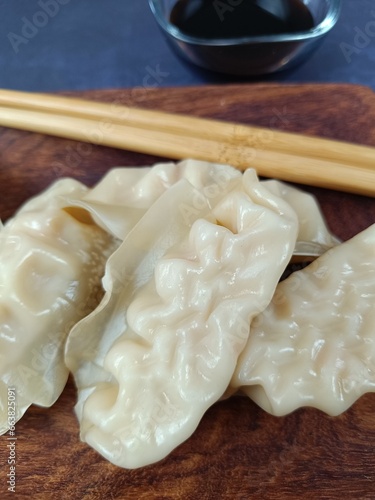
[0, 0, 375, 91]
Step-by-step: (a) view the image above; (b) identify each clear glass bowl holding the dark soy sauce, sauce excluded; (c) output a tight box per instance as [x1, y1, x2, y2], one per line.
[149, 0, 341, 76]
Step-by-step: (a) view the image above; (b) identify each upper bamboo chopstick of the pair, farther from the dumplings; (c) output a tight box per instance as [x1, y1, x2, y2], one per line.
[0, 89, 375, 168]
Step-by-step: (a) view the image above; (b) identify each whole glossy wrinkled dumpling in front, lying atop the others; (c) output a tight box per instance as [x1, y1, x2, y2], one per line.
[66, 167, 298, 468]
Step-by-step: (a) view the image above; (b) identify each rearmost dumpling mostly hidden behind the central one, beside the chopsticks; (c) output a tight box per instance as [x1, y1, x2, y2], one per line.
[64, 159, 339, 255]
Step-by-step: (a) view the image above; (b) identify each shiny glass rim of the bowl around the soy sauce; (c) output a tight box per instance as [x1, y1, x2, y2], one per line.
[148, 0, 342, 46]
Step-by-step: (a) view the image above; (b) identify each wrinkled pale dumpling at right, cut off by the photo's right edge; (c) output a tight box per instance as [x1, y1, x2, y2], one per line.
[231, 225, 375, 416]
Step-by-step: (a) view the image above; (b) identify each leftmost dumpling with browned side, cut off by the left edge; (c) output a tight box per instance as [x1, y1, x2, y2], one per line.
[0, 179, 113, 434]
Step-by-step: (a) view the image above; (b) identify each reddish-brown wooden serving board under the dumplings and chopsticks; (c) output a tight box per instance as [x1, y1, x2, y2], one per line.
[0, 84, 375, 500]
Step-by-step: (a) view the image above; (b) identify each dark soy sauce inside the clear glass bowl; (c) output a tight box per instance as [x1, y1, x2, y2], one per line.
[170, 0, 314, 39]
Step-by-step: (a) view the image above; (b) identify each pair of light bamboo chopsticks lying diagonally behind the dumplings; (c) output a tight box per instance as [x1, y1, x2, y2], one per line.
[0, 90, 375, 196]
